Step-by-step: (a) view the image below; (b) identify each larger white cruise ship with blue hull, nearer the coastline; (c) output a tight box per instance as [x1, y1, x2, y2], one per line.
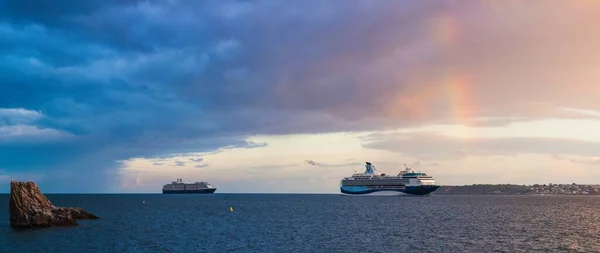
[340, 162, 440, 196]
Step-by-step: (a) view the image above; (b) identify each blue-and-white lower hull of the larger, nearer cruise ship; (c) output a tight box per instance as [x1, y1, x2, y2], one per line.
[340, 185, 440, 196]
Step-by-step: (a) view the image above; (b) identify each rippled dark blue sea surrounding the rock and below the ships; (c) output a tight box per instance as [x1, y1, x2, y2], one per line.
[0, 194, 600, 253]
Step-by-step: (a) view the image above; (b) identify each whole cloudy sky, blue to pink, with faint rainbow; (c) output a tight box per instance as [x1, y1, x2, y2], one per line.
[0, 0, 600, 193]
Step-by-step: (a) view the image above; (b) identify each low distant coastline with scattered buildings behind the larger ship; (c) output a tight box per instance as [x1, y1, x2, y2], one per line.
[432, 183, 600, 195]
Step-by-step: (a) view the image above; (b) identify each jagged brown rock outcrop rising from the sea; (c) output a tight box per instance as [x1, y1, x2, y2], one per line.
[9, 181, 99, 228]
